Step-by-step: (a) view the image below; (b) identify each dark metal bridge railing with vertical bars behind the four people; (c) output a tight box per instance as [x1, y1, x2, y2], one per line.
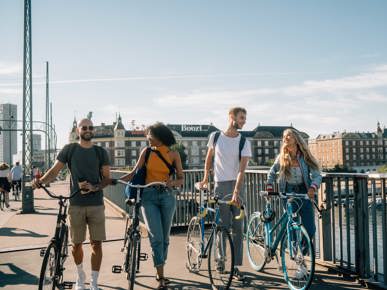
[105, 170, 387, 286]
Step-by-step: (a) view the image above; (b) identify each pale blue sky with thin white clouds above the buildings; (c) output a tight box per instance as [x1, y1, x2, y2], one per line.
[0, 0, 387, 146]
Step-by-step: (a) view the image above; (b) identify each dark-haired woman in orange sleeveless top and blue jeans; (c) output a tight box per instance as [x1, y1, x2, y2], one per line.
[120, 123, 184, 289]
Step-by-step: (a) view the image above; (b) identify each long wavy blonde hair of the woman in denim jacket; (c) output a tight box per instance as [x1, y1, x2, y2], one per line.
[279, 128, 320, 179]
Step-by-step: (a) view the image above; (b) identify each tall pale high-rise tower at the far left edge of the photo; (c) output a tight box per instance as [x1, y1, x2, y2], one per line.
[0, 104, 17, 164]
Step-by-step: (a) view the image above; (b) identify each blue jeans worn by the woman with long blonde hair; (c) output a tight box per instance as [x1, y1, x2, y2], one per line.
[285, 184, 316, 239]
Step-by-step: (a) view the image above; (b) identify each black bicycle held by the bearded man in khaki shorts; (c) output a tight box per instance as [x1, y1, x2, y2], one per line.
[39, 185, 79, 290]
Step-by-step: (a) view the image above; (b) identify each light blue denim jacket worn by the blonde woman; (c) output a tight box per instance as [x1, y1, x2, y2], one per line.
[267, 154, 322, 192]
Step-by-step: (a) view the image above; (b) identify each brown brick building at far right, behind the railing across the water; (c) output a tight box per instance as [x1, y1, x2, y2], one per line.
[309, 122, 387, 172]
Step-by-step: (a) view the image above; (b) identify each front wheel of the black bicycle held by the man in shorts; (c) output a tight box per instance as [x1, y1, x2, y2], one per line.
[39, 243, 57, 290]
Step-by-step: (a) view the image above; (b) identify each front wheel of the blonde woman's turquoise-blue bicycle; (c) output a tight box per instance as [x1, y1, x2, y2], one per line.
[281, 224, 315, 290]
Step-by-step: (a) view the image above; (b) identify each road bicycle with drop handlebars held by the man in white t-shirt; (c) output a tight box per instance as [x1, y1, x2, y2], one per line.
[186, 184, 244, 289]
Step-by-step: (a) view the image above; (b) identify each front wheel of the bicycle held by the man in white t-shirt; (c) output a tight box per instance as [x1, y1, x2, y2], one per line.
[208, 228, 234, 289]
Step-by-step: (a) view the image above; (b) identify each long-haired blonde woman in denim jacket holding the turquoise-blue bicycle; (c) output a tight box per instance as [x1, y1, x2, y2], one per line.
[267, 129, 322, 238]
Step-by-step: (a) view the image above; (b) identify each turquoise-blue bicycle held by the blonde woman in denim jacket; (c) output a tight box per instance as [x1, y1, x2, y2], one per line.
[246, 191, 321, 290]
